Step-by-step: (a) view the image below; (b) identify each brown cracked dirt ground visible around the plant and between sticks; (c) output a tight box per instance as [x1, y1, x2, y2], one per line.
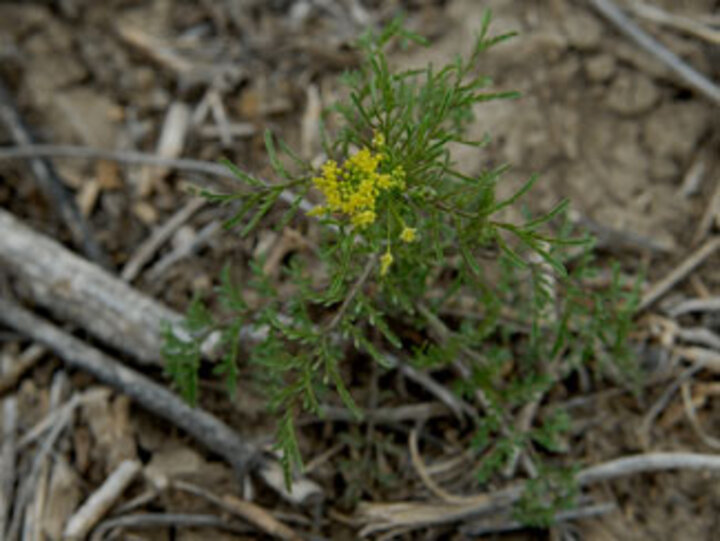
[0, 0, 720, 541]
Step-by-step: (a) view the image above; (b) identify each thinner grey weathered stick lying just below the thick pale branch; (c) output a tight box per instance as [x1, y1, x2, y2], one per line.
[0, 299, 259, 475]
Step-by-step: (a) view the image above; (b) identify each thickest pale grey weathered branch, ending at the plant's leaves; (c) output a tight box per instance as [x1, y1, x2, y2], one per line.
[0, 209, 181, 365]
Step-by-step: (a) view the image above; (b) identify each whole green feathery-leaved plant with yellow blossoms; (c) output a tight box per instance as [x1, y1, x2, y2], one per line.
[166, 10, 636, 523]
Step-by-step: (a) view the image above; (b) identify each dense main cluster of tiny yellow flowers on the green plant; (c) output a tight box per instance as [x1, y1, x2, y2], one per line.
[309, 134, 405, 228]
